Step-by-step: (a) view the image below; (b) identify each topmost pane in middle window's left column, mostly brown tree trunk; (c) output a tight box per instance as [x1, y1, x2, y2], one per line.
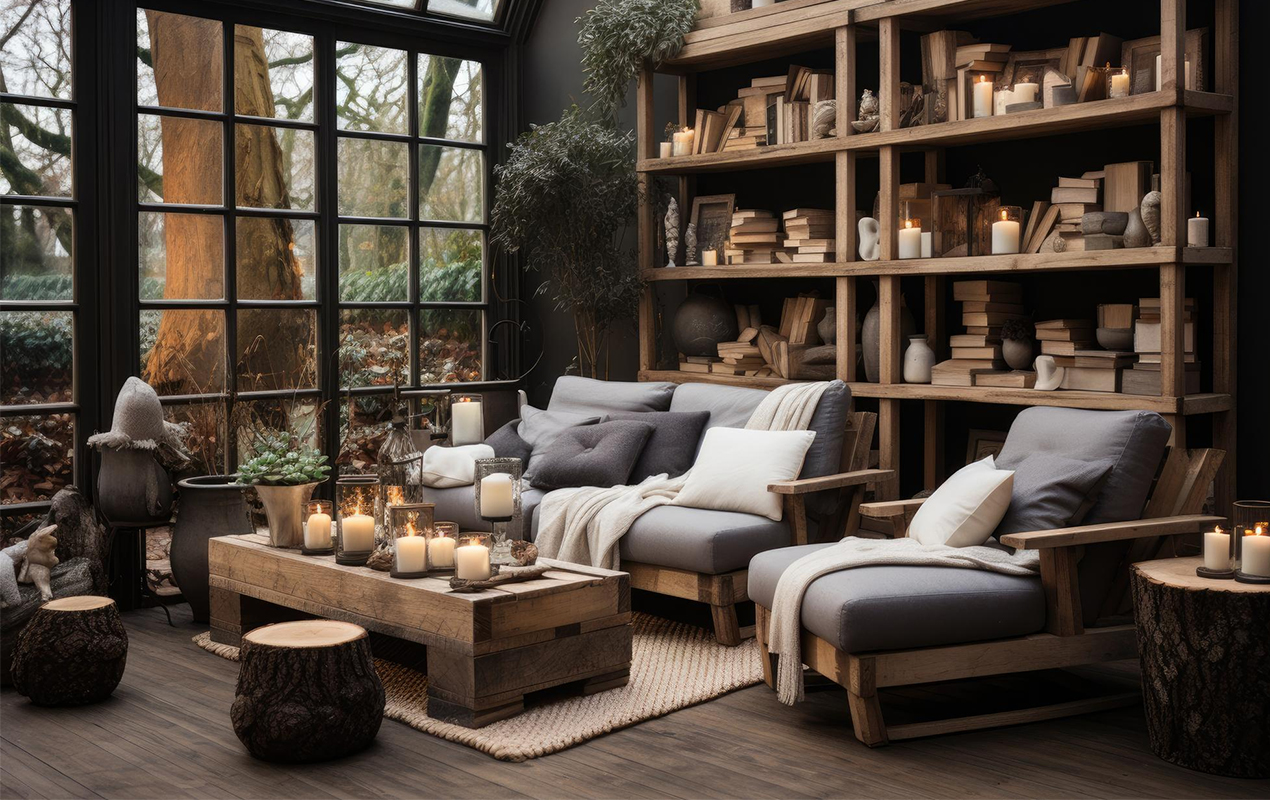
[137, 9, 225, 112]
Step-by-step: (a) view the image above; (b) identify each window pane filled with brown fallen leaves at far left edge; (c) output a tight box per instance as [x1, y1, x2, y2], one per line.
[0, 414, 75, 505]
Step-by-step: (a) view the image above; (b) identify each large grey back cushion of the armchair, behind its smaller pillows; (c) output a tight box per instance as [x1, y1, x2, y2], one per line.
[996, 408, 1172, 625]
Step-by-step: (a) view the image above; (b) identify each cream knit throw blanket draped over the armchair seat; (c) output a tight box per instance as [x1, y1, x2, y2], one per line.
[767, 536, 1040, 706]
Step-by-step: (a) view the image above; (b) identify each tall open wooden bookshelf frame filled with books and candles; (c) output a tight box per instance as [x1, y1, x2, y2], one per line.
[636, 0, 1238, 508]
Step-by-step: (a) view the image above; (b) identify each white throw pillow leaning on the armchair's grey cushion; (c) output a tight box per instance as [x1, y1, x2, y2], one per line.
[908, 456, 1015, 547]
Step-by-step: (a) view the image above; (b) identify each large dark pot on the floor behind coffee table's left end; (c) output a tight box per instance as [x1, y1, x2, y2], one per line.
[171, 475, 255, 622]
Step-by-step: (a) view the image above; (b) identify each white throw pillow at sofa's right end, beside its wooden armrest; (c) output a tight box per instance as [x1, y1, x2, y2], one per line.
[674, 428, 815, 522]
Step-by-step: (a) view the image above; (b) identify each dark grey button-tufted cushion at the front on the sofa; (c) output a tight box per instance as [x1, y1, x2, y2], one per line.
[531, 420, 653, 491]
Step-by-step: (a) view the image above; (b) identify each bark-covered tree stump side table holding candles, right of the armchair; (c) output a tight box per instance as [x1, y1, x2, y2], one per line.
[1130, 557, 1270, 777]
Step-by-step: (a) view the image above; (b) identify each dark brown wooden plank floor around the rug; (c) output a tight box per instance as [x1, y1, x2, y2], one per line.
[0, 606, 1270, 799]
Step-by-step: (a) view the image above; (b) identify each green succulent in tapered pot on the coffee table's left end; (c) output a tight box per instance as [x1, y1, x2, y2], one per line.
[237, 432, 330, 547]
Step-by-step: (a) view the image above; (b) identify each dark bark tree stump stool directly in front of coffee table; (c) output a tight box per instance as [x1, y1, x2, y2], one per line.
[230, 620, 384, 763]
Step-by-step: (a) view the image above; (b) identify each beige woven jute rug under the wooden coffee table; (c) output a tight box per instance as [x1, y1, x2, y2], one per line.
[194, 613, 763, 761]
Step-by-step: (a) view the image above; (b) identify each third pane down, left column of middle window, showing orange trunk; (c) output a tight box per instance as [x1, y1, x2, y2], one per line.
[137, 211, 225, 300]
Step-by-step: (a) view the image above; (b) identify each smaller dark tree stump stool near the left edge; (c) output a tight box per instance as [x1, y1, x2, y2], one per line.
[13, 596, 128, 706]
